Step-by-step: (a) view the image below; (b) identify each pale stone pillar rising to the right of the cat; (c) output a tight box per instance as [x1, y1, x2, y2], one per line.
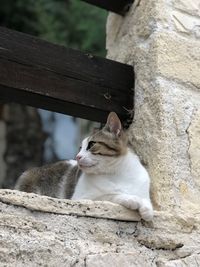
[107, 0, 200, 211]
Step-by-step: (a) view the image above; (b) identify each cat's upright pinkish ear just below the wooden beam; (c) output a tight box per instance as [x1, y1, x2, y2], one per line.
[106, 112, 122, 137]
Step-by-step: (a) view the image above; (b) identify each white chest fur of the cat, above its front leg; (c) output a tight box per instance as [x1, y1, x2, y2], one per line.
[72, 151, 149, 200]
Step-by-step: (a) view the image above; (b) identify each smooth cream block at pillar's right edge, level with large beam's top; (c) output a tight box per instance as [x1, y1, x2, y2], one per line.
[153, 33, 200, 89]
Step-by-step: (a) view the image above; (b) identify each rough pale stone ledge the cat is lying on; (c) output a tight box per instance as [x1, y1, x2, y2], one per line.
[0, 190, 200, 267]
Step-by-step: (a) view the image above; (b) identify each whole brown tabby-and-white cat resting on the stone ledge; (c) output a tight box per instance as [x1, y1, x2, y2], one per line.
[16, 112, 153, 221]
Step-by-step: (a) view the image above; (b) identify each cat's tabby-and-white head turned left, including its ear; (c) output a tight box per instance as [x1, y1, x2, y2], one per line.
[76, 112, 127, 174]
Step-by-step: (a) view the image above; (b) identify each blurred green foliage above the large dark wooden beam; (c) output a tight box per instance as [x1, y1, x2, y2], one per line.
[0, 0, 107, 56]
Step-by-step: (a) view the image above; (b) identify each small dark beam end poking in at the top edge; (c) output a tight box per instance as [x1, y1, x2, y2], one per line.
[82, 0, 134, 15]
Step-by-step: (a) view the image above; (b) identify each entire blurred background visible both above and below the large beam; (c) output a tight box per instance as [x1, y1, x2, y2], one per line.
[0, 0, 107, 188]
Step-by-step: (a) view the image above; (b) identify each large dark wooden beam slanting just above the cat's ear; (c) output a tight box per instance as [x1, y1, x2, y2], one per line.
[0, 27, 134, 122]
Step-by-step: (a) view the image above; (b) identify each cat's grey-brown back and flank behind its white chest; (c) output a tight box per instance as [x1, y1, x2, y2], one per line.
[15, 160, 81, 199]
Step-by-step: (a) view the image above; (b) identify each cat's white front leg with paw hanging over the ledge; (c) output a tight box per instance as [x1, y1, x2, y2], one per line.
[111, 194, 153, 221]
